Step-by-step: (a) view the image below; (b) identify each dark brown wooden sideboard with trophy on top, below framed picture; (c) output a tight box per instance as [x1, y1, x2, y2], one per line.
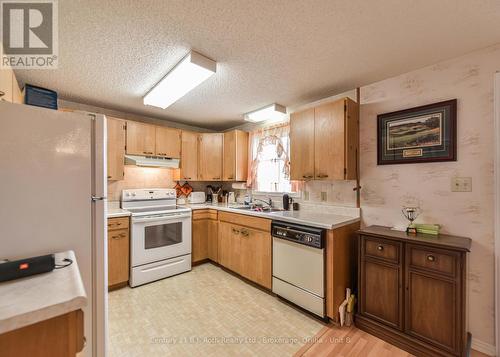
[355, 226, 471, 356]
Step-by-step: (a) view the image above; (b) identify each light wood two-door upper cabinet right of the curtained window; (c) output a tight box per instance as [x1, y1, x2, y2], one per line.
[290, 98, 359, 180]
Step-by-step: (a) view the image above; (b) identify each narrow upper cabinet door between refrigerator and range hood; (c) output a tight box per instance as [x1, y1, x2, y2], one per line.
[107, 117, 125, 180]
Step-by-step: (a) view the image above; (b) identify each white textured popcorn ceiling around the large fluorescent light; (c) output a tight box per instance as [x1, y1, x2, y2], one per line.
[13, 0, 500, 129]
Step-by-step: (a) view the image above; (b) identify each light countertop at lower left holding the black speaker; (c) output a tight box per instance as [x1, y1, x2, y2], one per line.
[0, 251, 87, 334]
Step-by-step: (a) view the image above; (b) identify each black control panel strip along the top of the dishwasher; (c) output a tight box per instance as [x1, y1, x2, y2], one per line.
[271, 222, 325, 249]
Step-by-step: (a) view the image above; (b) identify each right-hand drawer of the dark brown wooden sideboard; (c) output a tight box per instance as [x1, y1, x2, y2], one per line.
[406, 244, 458, 277]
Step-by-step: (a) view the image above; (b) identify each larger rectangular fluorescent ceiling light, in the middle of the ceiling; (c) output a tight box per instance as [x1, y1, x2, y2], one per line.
[144, 51, 217, 109]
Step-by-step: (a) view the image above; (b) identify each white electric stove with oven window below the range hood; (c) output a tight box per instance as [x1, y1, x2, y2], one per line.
[121, 188, 191, 287]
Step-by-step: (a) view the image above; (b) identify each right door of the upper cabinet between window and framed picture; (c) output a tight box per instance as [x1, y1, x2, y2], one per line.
[314, 99, 345, 180]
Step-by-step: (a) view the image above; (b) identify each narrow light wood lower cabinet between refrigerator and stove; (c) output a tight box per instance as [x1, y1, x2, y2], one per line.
[108, 217, 130, 289]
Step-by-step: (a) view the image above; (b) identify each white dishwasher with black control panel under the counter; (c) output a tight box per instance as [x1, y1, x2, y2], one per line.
[271, 221, 325, 318]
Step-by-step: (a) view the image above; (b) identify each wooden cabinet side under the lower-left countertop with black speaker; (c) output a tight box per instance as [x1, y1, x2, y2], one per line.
[0, 310, 85, 357]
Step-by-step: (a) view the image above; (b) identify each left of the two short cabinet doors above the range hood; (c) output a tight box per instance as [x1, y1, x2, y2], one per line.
[127, 121, 156, 155]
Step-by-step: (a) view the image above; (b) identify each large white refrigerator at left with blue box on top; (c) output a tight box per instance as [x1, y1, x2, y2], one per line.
[0, 102, 107, 356]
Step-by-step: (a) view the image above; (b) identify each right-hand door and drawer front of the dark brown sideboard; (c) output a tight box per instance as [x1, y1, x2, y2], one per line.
[405, 244, 465, 355]
